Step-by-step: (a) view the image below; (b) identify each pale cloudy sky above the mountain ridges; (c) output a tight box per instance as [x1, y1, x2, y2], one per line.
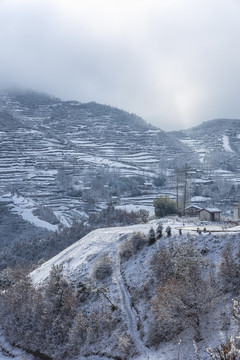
[0, 0, 240, 130]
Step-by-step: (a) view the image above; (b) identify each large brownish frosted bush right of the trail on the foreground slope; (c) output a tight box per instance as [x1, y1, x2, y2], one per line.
[153, 244, 217, 341]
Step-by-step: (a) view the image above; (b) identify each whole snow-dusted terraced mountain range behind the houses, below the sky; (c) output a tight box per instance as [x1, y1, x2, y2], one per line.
[0, 91, 240, 239]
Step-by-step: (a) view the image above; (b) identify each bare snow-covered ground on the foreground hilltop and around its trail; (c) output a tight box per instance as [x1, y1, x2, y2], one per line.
[31, 217, 240, 360]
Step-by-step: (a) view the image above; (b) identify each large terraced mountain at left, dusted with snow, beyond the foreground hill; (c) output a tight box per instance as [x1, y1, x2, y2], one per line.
[0, 91, 192, 225]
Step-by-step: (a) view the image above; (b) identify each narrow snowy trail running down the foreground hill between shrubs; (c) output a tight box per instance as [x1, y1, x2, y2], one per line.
[111, 239, 147, 355]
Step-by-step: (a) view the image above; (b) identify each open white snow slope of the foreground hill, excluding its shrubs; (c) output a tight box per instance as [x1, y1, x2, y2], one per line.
[31, 218, 240, 360]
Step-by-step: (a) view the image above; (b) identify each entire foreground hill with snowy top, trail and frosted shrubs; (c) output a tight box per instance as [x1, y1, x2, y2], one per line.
[0, 218, 240, 360]
